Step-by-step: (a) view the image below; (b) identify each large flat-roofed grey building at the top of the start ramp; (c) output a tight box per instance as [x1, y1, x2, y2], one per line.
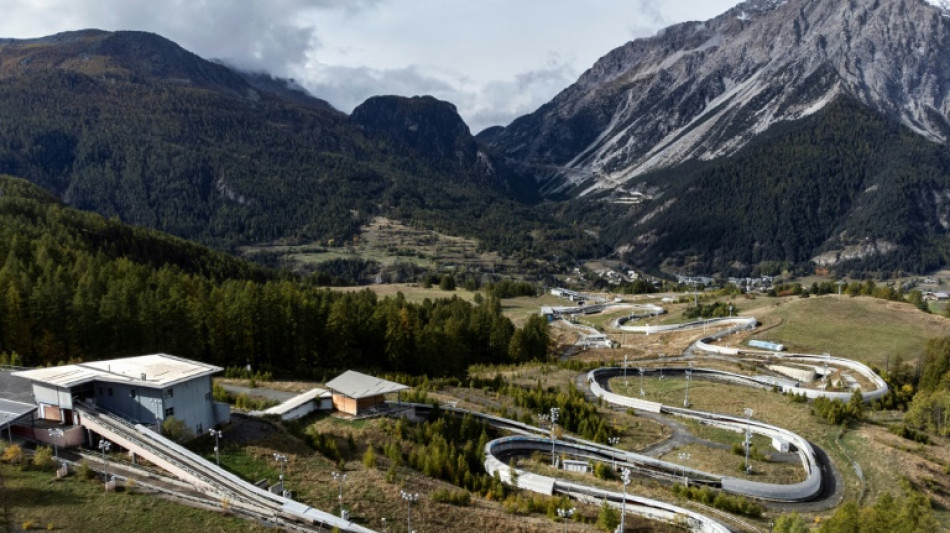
[13, 354, 230, 435]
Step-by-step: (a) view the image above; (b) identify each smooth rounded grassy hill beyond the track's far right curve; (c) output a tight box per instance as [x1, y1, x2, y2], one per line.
[756, 296, 950, 367]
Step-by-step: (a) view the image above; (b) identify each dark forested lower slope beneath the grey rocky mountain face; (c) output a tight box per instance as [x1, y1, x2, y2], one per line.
[565, 100, 950, 275]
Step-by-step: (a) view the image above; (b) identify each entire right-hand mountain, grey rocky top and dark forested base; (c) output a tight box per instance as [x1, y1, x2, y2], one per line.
[479, 0, 950, 273]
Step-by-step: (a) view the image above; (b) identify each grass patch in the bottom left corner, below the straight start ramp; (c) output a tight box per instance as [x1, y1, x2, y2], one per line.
[0, 465, 268, 533]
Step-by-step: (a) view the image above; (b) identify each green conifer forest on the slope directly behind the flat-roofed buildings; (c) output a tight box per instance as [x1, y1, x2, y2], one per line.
[0, 176, 548, 377]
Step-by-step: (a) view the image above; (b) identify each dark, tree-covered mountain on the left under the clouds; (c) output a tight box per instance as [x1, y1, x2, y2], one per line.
[0, 30, 593, 255]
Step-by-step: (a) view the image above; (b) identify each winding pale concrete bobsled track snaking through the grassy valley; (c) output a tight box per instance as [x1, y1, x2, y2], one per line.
[415, 308, 887, 532]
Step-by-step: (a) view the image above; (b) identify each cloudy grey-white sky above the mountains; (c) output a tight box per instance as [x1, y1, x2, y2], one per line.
[0, 0, 739, 133]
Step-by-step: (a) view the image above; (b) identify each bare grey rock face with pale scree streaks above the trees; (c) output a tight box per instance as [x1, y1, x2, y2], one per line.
[482, 0, 950, 194]
